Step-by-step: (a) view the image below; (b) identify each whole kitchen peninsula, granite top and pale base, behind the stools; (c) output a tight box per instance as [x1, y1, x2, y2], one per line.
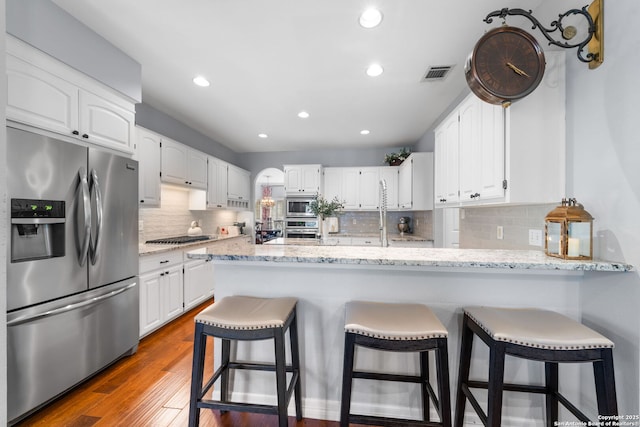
[187, 241, 633, 425]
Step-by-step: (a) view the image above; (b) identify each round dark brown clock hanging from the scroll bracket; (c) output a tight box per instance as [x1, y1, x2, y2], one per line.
[465, 25, 545, 107]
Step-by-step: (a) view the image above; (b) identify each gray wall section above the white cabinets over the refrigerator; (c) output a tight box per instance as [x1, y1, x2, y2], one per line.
[3, 0, 142, 101]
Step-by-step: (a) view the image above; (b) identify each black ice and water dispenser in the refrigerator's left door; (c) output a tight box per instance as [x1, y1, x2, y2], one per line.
[11, 199, 65, 262]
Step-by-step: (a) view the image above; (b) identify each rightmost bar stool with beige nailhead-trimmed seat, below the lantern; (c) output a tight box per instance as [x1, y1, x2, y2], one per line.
[454, 307, 618, 427]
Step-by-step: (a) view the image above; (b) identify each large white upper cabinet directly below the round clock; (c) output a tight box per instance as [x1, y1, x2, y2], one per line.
[435, 52, 566, 207]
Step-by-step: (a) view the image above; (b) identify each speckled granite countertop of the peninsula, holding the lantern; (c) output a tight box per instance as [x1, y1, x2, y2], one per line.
[187, 239, 633, 271]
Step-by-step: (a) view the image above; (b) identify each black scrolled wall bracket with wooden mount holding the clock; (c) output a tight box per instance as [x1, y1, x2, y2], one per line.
[483, 0, 604, 69]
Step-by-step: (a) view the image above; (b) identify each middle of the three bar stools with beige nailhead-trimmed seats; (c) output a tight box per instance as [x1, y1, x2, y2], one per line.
[340, 301, 451, 427]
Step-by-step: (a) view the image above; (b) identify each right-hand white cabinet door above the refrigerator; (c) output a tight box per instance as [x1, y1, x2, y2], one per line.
[79, 90, 136, 152]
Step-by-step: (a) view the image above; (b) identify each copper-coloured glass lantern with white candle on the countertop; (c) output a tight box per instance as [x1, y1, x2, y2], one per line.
[544, 199, 593, 260]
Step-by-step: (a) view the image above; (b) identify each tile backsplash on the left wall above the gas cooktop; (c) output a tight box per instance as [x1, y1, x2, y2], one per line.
[138, 185, 239, 242]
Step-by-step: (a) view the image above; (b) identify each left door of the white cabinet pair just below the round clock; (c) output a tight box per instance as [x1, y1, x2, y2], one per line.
[458, 96, 482, 202]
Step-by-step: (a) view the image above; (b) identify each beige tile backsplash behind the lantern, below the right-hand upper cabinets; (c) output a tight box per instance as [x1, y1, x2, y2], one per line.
[460, 204, 557, 251]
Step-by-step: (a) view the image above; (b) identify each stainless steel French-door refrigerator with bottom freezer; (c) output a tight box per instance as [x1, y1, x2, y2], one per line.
[6, 127, 139, 424]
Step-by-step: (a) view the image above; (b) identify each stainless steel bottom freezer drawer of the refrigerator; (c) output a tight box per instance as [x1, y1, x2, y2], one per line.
[7, 277, 139, 424]
